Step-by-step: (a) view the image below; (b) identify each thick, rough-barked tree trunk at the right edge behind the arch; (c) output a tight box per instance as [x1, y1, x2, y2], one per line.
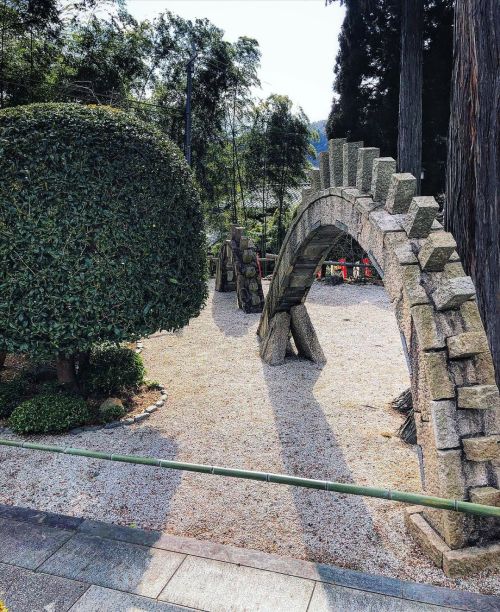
[445, 0, 500, 384]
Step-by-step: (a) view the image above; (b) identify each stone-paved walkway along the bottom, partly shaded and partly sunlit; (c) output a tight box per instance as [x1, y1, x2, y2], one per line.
[0, 505, 500, 612]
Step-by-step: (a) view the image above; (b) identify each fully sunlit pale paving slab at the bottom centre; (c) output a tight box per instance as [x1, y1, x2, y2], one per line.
[159, 557, 314, 612]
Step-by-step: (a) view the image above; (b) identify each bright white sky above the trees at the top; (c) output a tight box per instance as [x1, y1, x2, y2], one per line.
[127, 0, 344, 121]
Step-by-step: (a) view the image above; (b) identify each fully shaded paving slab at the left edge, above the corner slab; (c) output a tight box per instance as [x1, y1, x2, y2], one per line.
[0, 518, 73, 569]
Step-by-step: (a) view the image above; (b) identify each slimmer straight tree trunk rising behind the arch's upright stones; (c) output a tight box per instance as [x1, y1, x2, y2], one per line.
[398, 0, 424, 193]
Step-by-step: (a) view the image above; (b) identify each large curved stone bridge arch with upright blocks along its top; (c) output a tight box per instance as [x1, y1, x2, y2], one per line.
[258, 139, 500, 575]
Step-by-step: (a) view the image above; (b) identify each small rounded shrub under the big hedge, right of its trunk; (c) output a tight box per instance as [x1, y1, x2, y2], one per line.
[86, 346, 145, 394]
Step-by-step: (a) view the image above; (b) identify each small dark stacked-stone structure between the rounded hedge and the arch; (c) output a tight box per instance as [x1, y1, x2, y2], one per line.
[215, 226, 264, 313]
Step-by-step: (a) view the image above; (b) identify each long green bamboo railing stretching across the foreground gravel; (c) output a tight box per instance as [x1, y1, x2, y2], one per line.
[0, 438, 500, 518]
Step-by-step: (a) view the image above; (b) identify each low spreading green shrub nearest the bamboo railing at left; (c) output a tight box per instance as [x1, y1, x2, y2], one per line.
[9, 393, 90, 434]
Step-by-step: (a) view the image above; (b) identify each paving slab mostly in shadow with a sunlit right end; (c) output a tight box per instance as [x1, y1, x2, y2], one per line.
[40, 534, 184, 597]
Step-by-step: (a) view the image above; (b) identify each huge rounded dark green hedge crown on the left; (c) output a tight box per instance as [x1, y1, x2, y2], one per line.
[0, 104, 206, 356]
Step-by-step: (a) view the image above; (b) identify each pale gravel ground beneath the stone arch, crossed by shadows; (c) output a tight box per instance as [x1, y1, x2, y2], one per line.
[0, 283, 500, 593]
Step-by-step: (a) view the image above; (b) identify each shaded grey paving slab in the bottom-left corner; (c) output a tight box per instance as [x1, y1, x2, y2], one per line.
[0, 565, 86, 612]
